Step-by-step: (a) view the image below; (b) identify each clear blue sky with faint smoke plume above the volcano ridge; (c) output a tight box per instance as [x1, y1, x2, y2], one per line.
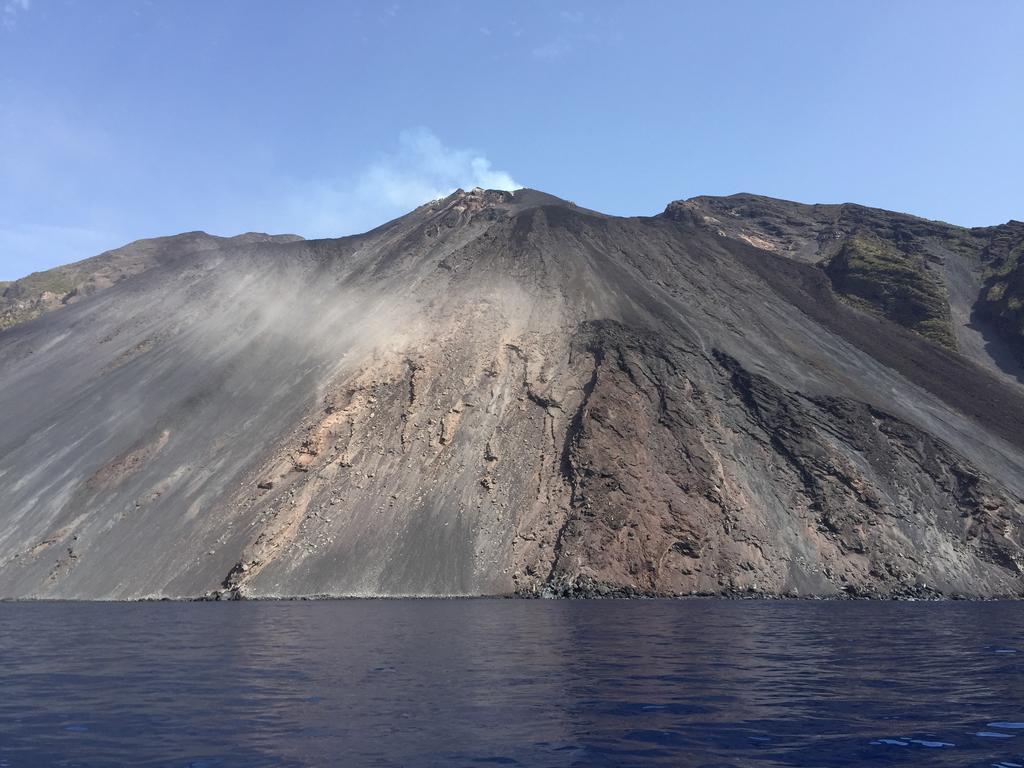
[0, 0, 1024, 280]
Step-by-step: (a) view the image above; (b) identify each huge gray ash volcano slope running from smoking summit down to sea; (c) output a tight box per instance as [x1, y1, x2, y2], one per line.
[0, 189, 1024, 599]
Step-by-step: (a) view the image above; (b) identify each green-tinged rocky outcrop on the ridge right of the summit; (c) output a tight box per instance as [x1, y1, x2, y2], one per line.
[825, 231, 956, 349]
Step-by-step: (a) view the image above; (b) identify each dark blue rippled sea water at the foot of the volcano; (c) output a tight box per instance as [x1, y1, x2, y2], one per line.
[0, 600, 1024, 768]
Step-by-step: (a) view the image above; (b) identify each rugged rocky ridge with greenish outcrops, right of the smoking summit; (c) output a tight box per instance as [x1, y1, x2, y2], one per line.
[667, 195, 1024, 381]
